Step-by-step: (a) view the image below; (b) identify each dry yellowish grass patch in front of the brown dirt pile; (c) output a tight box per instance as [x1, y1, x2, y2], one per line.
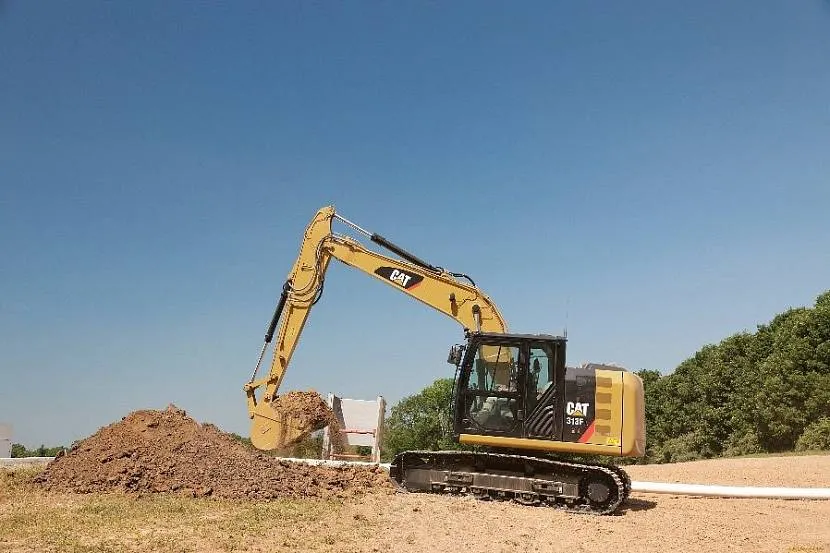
[0, 469, 378, 553]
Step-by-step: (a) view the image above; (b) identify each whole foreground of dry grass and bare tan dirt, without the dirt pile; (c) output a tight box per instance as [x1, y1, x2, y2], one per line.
[0, 455, 830, 553]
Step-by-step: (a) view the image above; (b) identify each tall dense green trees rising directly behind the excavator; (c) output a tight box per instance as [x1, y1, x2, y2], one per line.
[383, 291, 830, 463]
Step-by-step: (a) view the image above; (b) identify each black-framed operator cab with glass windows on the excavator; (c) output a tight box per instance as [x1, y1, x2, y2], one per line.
[447, 332, 572, 440]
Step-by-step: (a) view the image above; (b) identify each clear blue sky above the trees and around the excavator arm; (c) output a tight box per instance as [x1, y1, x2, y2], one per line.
[0, 0, 830, 447]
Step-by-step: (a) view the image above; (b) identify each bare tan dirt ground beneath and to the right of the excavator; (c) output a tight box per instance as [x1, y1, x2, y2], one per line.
[351, 455, 830, 553]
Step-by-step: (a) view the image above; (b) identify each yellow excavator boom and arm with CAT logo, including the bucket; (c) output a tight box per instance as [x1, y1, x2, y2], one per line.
[244, 206, 507, 450]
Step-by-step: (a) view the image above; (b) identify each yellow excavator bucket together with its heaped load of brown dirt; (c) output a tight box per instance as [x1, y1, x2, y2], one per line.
[250, 392, 337, 450]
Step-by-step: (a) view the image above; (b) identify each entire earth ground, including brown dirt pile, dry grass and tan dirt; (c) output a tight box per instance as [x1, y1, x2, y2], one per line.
[0, 406, 830, 553]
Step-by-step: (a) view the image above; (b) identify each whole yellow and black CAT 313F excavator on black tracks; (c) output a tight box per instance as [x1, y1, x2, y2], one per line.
[244, 206, 645, 514]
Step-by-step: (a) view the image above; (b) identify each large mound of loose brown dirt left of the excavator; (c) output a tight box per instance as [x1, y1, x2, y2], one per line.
[36, 405, 392, 499]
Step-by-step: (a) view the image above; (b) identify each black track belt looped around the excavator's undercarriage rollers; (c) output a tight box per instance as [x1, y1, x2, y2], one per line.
[389, 451, 631, 515]
